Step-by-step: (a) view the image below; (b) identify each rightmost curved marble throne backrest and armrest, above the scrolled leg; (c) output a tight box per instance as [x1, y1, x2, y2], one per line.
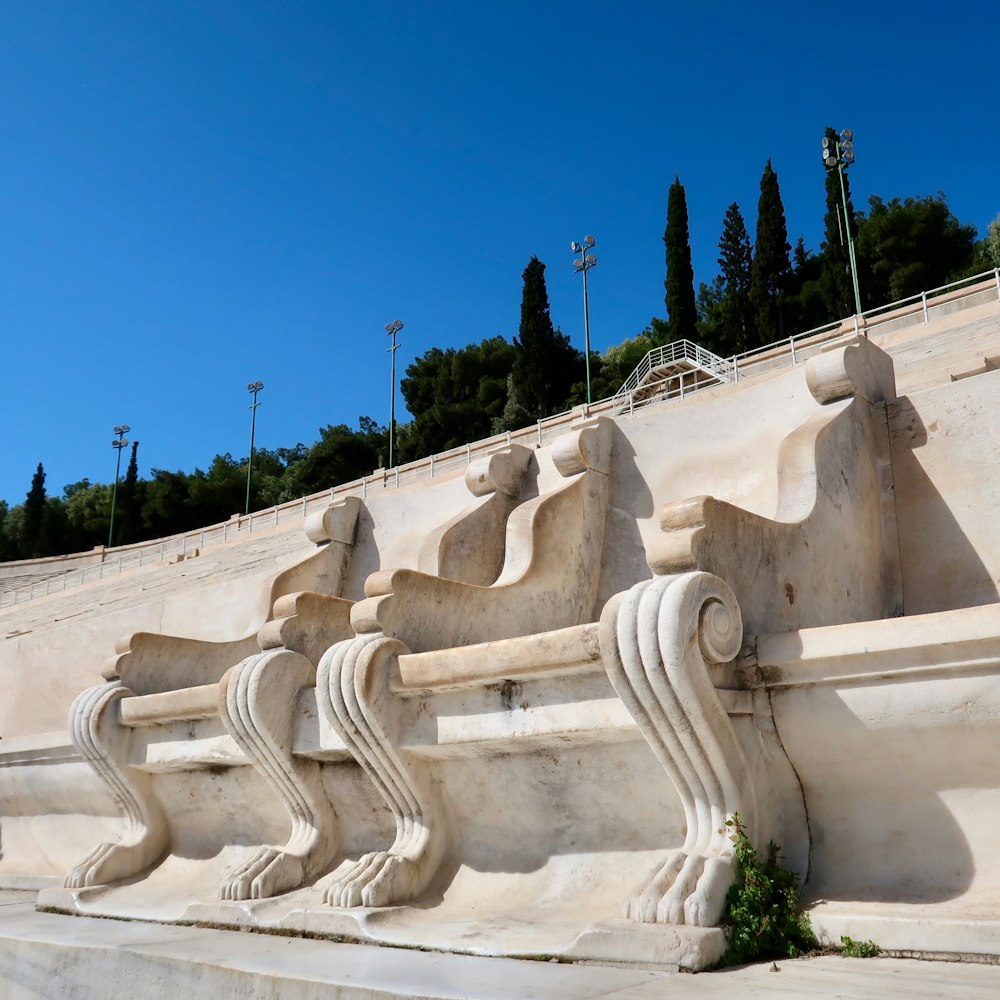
[648, 340, 900, 634]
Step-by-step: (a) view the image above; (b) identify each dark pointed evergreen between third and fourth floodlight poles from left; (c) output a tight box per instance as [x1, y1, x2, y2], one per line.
[503, 257, 584, 430]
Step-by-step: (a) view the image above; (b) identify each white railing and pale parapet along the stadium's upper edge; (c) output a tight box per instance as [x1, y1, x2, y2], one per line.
[0, 268, 1000, 608]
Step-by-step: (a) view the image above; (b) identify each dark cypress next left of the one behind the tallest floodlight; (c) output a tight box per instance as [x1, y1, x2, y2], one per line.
[750, 160, 792, 346]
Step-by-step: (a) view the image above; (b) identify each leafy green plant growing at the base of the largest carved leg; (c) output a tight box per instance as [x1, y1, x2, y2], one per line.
[720, 813, 816, 965]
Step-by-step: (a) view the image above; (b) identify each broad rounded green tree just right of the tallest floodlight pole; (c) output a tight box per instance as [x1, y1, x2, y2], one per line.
[857, 192, 976, 304]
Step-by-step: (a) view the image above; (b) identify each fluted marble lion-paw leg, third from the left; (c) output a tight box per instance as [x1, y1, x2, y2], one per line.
[316, 633, 446, 907]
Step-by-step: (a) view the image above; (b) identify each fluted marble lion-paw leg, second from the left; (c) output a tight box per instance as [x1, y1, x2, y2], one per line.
[219, 649, 337, 899]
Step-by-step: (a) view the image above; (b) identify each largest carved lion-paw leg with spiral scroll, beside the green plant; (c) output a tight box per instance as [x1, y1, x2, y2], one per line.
[601, 573, 756, 927]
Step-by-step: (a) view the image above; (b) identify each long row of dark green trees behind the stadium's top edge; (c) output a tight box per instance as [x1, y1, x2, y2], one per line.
[0, 135, 1000, 560]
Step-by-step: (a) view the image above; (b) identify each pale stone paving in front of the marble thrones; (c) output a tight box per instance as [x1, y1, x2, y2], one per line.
[0, 893, 1000, 1000]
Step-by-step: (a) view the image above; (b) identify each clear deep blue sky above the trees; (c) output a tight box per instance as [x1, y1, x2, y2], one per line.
[0, 0, 1000, 504]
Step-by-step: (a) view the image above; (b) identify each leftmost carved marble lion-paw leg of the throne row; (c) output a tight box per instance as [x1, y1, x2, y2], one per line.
[65, 681, 168, 889]
